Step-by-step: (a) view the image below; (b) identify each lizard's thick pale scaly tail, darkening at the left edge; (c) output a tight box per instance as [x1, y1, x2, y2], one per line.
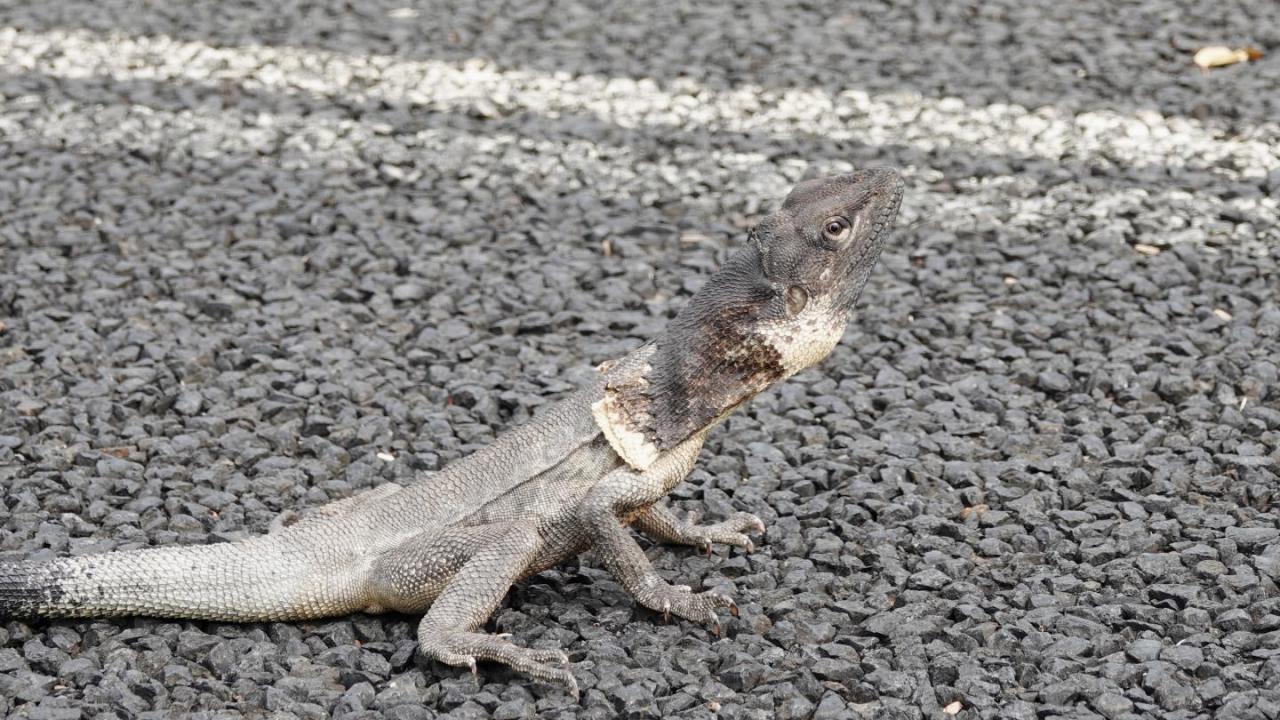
[0, 536, 371, 621]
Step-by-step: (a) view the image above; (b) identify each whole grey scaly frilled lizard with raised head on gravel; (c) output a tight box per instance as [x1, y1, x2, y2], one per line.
[0, 168, 904, 696]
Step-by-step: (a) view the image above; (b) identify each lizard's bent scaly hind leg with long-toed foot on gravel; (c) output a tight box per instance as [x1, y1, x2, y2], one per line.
[373, 524, 577, 694]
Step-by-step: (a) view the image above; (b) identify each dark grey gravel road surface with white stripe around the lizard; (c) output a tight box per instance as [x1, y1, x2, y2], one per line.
[0, 0, 1280, 720]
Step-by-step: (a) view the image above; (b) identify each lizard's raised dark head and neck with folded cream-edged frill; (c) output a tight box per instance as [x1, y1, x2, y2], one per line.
[595, 169, 902, 468]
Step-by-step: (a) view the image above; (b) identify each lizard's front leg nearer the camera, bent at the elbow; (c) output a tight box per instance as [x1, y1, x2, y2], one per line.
[577, 470, 737, 633]
